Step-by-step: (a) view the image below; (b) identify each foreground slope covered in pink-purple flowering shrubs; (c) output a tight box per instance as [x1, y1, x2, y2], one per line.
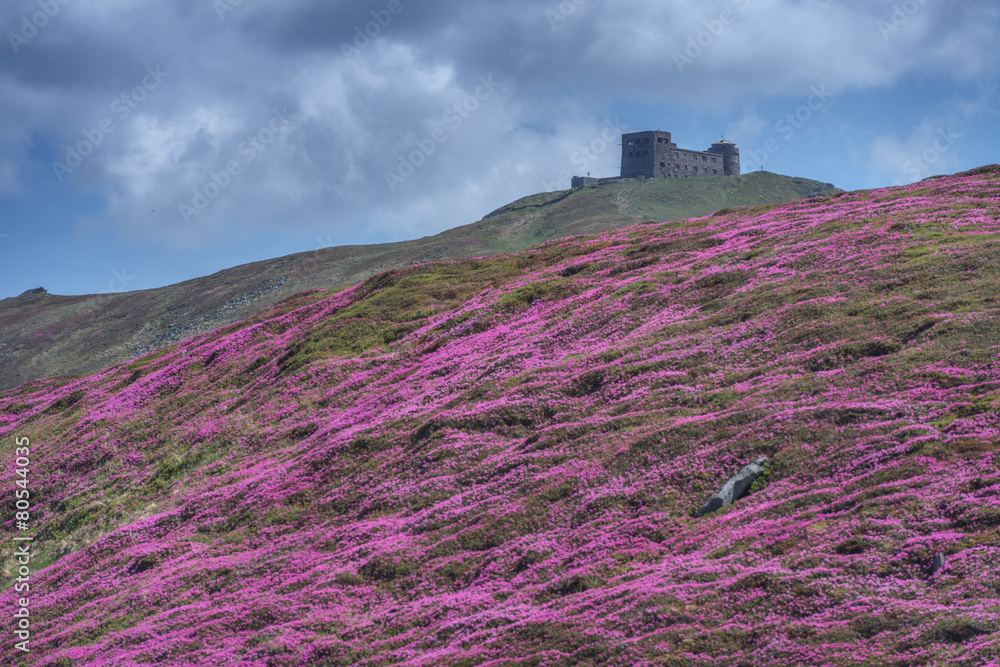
[0, 167, 1000, 667]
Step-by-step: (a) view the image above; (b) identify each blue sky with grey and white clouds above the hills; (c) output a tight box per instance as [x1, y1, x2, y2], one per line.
[0, 0, 1000, 298]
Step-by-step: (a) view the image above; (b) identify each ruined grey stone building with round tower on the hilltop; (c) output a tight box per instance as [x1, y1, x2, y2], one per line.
[572, 130, 740, 188]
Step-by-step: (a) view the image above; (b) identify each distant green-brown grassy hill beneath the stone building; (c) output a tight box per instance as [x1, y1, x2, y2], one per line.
[0, 172, 839, 389]
